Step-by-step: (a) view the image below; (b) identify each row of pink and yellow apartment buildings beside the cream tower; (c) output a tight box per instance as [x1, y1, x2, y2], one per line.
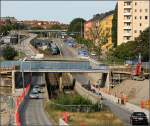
[84, 11, 114, 54]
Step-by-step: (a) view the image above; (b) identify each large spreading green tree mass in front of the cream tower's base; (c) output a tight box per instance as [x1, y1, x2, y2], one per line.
[108, 27, 150, 61]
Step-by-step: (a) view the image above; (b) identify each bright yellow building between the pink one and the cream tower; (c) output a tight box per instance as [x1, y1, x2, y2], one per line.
[99, 14, 113, 54]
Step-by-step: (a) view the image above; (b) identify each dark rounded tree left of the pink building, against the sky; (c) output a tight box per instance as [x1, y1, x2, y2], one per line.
[68, 18, 85, 36]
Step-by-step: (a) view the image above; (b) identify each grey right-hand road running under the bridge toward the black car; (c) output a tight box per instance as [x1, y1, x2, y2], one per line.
[54, 39, 132, 126]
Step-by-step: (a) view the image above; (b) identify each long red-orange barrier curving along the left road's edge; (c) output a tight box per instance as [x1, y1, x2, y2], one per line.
[15, 83, 30, 126]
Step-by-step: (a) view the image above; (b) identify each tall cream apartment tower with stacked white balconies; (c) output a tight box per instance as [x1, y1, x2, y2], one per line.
[117, 0, 150, 45]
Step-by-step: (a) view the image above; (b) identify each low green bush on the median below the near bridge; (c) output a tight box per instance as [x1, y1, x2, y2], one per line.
[49, 94, 101, 112]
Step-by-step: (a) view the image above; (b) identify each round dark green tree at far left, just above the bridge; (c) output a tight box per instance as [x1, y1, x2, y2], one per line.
[3, 46, 17, 60]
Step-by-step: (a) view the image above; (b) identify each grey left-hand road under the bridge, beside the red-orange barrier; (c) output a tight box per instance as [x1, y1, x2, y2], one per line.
[20, 74, 52, 126]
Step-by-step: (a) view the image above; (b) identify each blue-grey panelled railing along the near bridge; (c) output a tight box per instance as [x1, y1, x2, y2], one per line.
[0, 61, 91, 70]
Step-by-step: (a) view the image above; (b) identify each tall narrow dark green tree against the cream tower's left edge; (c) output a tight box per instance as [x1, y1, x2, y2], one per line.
[111, 4, 118, 47]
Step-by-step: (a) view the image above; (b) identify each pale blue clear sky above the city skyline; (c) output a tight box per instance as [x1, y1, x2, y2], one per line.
[1, 1, 116, 24]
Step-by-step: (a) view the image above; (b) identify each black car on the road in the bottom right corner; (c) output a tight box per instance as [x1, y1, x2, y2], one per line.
[130, 112, 148, 126]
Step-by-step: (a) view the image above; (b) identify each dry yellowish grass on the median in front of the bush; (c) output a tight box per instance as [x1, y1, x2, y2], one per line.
[45, 102, 123, 126]
